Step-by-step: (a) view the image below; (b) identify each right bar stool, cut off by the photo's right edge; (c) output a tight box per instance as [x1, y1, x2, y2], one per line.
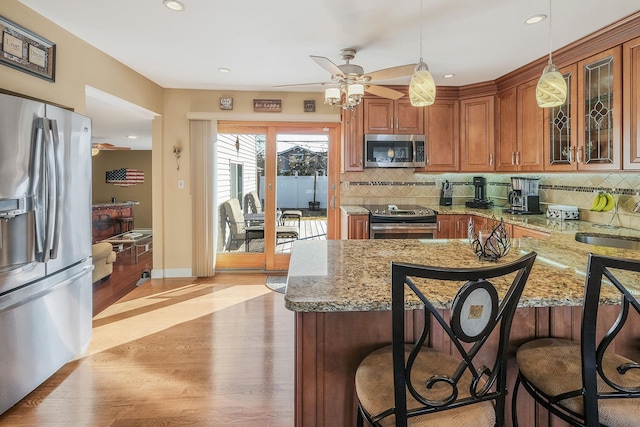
[512, 254, 640, 427]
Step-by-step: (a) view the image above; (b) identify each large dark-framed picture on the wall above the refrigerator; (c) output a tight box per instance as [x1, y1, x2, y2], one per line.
[0, 16, 56, 82]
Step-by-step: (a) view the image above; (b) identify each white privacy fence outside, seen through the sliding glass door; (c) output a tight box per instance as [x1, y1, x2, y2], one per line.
[260, 176, 327, 209]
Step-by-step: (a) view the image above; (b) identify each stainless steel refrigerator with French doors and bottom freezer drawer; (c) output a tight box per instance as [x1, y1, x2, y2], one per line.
[0, 94, 93, 413]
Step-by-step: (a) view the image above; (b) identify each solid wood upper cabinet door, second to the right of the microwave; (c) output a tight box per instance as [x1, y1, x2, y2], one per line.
[460, 96, 495, 172]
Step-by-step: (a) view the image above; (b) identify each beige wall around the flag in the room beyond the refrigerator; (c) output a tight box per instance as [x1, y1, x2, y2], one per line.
[91, 150, 153, 228]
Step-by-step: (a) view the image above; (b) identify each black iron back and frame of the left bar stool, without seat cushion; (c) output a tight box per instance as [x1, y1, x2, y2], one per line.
[356, 252, 536, 426]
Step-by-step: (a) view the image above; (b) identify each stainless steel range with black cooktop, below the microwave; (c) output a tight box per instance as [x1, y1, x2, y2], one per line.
[365, 205, 437, 239]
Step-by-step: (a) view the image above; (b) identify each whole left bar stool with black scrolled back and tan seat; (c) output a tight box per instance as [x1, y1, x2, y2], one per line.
[355, 252, 537, 427]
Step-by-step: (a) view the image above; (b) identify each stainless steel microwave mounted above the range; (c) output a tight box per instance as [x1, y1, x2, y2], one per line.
[364, 134, 426, 168]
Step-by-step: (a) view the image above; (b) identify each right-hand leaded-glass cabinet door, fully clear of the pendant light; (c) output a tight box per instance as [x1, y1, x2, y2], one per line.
[576, 46, 622, 170]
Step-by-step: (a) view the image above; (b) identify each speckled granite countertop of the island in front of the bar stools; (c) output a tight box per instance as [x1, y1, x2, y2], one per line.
[285, 233, 640, 312]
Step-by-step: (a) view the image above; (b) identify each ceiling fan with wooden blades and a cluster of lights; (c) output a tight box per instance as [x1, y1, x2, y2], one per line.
[276, 48, 416, 108]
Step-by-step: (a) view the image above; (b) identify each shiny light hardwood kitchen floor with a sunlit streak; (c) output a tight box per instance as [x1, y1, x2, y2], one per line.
[0, 272, 294, 427]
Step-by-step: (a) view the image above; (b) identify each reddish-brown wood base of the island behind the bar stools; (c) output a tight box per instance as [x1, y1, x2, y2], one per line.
[295, 306, 640, 427]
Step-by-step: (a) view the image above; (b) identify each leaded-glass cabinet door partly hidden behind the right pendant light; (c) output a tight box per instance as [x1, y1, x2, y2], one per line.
[544, 64, 578, 171]
